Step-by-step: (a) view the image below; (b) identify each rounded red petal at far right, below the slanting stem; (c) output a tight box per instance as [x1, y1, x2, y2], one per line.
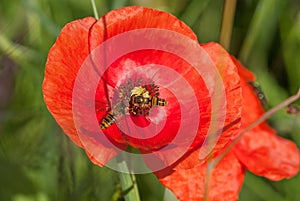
[234, 123, 300, 180]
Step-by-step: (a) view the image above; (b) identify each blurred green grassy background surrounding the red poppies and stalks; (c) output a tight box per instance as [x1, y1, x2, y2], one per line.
[0, 0, 300, 201]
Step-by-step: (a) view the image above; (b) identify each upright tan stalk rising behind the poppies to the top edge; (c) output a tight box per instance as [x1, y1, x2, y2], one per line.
[220, 0, 236, 50]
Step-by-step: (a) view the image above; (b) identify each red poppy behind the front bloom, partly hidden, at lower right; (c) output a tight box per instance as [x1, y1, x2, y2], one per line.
[157, 43, 299, 200]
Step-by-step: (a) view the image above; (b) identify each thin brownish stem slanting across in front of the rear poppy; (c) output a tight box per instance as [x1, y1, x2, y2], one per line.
[204, 88, 300, 200]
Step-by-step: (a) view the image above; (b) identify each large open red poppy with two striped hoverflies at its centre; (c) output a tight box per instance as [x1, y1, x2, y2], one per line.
[43, 6, 241, 170]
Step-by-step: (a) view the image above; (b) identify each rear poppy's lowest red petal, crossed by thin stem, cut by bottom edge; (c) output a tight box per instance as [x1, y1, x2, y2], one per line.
[156, 152, 245, 201]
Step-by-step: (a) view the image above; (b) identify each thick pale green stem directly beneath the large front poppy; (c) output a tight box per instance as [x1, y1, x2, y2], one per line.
[118, 161, 140, 201]
